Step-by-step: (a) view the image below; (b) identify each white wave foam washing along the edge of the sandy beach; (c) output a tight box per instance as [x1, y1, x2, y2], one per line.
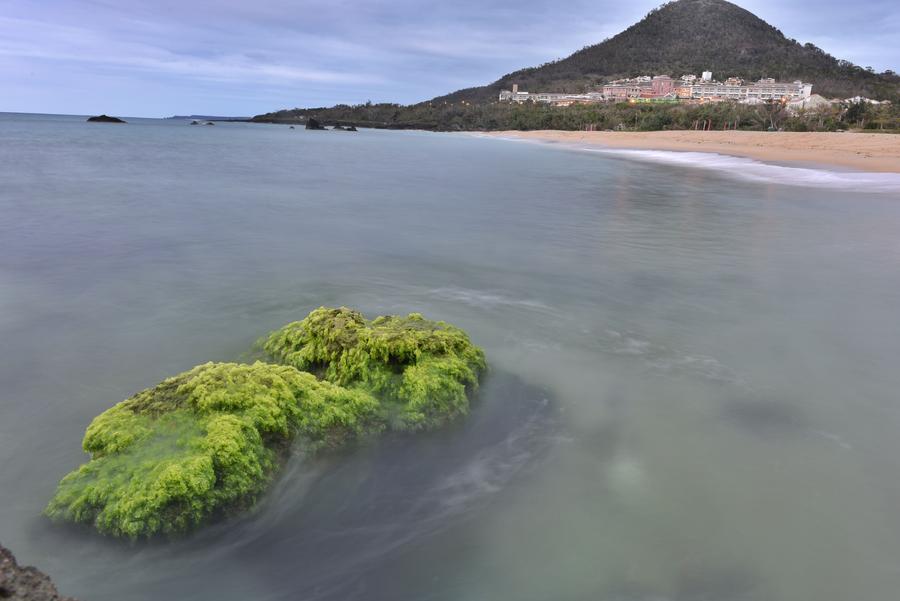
[581, 147, 900, 193]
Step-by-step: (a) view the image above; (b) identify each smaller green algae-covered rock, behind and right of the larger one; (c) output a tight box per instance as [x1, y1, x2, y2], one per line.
[263, 307, 485, 430]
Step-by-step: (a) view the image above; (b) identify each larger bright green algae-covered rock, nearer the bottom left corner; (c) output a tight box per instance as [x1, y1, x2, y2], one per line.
[46, 363, 382, 538]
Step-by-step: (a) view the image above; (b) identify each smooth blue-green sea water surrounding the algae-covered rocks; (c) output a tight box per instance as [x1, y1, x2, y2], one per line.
[0, 115, 900, 601]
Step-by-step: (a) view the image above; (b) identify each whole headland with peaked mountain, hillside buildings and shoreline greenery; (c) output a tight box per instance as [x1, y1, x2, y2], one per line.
[252, 0, 900, 131]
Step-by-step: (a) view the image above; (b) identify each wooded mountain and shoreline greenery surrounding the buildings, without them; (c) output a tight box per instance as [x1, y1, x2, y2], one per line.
[253, 0, 900, 131]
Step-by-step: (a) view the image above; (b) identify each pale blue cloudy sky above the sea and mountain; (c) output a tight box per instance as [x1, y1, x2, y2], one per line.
[0, 0, 900, 117]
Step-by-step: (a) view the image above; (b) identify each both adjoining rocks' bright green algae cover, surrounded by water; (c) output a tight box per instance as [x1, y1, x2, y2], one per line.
[45, 307, 485, 539]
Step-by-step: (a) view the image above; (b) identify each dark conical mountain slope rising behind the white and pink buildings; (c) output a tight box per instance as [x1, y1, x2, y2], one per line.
[432, 0, 900, 102]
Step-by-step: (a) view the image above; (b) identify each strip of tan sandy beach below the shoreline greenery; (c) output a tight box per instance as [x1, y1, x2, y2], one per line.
[489, 131, 900, 173]
